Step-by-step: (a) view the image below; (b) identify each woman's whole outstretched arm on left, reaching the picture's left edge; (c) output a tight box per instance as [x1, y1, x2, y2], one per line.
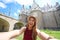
[0, 27, 26, 40]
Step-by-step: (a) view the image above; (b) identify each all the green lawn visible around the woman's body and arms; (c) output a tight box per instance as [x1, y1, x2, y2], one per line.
[16, 30, 60, 40]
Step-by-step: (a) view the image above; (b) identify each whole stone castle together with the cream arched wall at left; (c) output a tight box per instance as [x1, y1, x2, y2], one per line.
[0, 1, 60, 32]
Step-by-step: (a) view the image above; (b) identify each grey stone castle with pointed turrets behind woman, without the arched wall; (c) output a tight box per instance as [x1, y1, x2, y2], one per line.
[19, 1, 60, 29]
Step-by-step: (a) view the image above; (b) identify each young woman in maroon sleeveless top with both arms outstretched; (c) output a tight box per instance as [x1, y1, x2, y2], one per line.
[0, 16, 56, 40]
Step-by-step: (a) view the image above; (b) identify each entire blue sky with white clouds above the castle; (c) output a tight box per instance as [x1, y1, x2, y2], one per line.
[0, 0, 60, 19]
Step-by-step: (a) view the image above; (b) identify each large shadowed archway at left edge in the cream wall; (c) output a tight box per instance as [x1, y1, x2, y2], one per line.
[0, 18, 9, 32]
